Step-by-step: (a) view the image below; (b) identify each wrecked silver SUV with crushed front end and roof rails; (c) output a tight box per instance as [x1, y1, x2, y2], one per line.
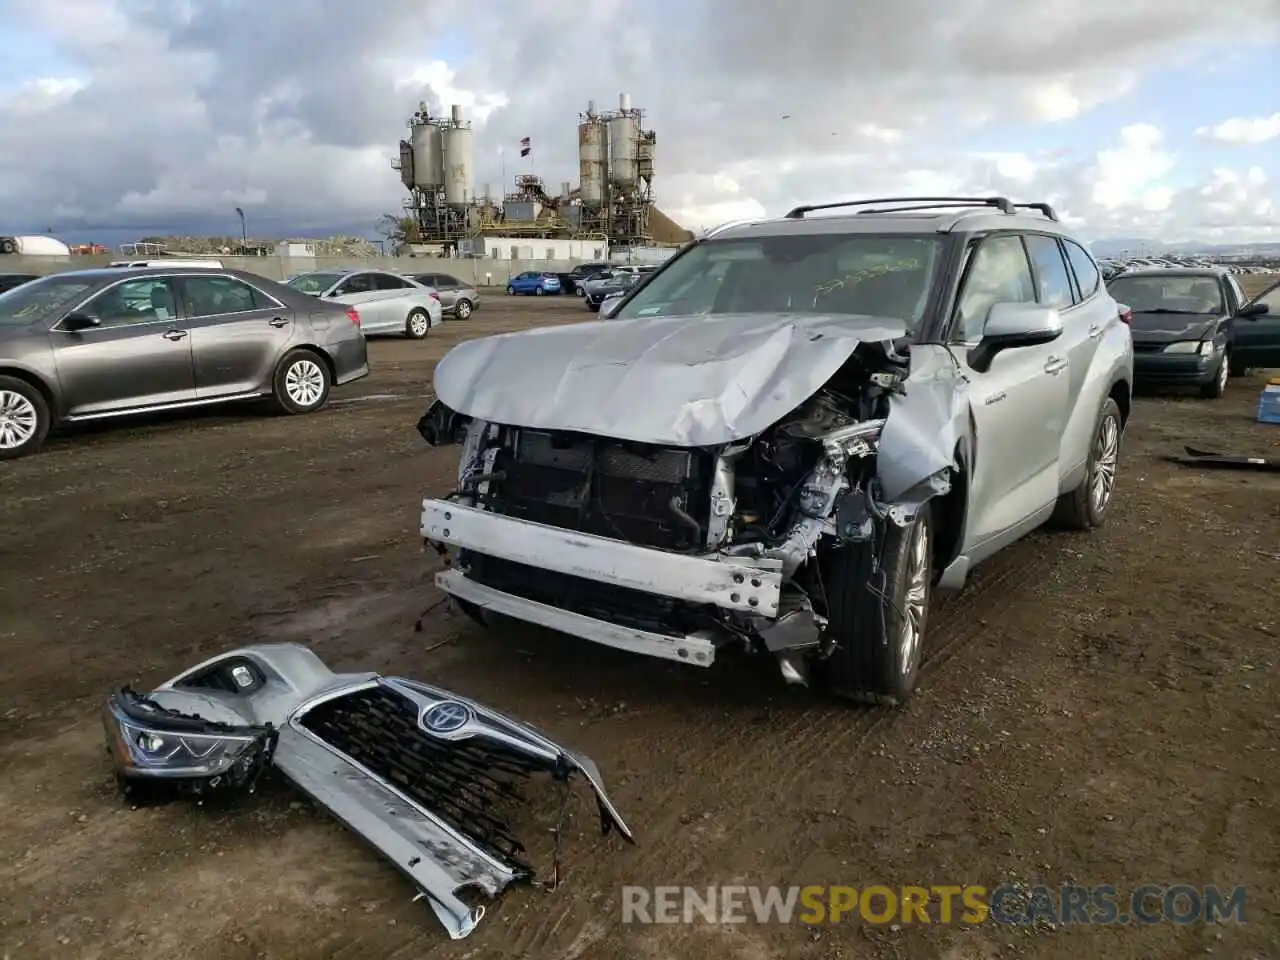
[419, 197, 1133, 703]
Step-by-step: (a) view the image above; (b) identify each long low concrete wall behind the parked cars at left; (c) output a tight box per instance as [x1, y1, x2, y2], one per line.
[0, 256, 596, 287]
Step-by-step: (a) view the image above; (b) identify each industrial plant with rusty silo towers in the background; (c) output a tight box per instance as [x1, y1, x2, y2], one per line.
[392, 93, 678, 259]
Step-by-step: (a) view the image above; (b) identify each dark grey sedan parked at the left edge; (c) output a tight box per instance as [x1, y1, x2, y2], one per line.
[0, 268, 369, 460]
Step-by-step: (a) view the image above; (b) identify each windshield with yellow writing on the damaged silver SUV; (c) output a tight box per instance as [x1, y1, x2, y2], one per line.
[614, 233, 942, 330]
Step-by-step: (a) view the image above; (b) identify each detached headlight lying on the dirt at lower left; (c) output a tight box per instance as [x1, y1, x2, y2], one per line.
[102, 689, 276, 792]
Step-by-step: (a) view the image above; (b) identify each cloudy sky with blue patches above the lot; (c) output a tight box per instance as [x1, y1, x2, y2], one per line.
[0, 0, 1280, 242]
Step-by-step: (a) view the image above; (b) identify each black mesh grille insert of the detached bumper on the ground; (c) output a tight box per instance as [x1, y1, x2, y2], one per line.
[298, 686, 550, 872]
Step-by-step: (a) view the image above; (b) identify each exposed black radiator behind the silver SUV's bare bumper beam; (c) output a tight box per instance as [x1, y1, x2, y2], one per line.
[485, 429, 713, 550]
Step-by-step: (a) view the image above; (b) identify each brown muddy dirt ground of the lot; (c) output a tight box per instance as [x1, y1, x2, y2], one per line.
[0, 296, 1280, 960]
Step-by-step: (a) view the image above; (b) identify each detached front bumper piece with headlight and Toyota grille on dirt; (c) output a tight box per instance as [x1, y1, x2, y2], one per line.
[102, 644, 635, 940]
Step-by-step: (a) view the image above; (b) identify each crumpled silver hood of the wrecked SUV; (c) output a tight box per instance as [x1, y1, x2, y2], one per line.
[435, 314, 906, 447]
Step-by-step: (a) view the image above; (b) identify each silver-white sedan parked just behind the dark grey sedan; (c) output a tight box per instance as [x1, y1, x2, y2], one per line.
[285, 270, 444, 340]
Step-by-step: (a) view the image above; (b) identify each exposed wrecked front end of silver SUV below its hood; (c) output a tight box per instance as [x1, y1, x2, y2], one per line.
[419, 340, 948, 682]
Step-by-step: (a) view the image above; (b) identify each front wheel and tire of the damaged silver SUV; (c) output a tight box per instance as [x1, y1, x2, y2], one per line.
[818, 507, 933, 705]
